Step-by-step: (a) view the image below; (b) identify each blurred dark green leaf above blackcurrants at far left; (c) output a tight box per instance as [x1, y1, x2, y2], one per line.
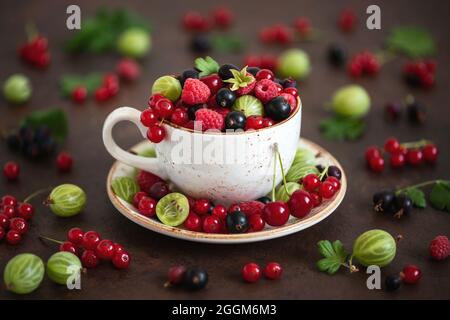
[21, 108, 69, 141]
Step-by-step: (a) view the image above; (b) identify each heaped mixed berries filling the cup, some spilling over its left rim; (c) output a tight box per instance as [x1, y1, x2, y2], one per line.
[141, 57, 298, 143]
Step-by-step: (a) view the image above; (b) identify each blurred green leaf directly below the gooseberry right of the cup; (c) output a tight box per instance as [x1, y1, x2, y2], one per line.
[320, 116, 366, 141]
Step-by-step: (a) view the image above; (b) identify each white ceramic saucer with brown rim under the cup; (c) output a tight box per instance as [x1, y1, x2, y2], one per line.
[106, 139, 347, 244]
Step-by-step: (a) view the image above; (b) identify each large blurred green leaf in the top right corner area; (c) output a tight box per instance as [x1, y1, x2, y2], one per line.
[386, 26, 436, 58]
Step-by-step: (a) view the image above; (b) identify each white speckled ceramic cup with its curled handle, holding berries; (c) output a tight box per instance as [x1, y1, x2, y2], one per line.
[103, 99, 302, 205]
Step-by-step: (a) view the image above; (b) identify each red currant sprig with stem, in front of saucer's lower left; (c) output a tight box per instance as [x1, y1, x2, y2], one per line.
[56, 228, 131, 269]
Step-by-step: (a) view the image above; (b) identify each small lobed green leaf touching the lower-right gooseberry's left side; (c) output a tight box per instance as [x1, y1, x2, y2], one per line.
[316, 240, 348, 274]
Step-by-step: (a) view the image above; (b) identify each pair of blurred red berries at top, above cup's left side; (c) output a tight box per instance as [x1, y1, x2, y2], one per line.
[182, 7, 233, 32]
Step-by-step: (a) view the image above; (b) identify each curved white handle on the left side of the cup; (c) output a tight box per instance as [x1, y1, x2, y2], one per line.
[103, 107, 167, 179]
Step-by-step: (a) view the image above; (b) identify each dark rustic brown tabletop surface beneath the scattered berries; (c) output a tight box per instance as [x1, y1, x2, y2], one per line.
[0, 0, 450, 299]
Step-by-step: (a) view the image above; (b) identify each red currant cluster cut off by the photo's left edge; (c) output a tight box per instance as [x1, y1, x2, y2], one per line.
[0, 195, 34, 245]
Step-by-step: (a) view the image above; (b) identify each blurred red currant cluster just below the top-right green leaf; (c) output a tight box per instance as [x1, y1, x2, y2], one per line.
[403, 60, 436, 89]
